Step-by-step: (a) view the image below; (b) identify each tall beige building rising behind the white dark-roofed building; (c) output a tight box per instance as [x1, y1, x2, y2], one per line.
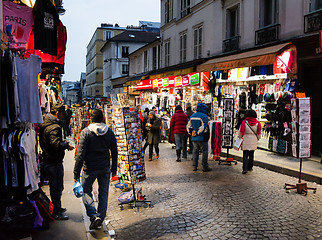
[85, 24, 125, 97]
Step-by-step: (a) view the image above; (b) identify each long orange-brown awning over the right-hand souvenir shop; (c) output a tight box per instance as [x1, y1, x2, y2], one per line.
[197, 42, 291, 72]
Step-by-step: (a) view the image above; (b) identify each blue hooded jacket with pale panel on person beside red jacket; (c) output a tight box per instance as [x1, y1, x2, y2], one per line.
[187, 103, 209, 142]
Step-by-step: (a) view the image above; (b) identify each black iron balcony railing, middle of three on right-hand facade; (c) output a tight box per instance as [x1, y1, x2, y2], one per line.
[255, 24, 280, 45]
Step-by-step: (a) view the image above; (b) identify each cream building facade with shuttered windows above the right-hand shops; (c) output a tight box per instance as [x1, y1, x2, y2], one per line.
[161, 0, 322, 154]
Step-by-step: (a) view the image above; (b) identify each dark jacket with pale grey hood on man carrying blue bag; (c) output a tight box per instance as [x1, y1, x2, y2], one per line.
[74, 123, 118, 179]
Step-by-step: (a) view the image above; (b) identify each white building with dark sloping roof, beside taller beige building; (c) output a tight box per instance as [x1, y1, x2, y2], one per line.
[101, 30, 159, 97]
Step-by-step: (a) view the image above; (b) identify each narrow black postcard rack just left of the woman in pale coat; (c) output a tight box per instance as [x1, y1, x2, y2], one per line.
[215, 98, 237, 166]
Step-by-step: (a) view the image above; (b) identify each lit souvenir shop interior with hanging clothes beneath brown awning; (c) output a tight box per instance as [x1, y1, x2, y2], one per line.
[200, 44, 299, 155]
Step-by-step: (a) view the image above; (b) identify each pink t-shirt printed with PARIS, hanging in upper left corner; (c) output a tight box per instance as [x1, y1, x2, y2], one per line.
[3, 1, 34, 49]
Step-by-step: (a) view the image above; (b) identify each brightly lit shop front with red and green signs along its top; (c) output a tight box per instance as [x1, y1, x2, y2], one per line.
[135, 72, 211, 116]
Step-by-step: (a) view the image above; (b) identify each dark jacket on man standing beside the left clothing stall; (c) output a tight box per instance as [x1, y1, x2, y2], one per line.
[39, 114, 69, 163]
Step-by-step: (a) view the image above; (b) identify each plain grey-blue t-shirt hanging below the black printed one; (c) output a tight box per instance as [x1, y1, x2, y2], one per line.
[15, 55, 43, 123]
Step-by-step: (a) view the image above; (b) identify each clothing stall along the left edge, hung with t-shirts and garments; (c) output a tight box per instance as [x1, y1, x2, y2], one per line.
[0, 0, 67, 238]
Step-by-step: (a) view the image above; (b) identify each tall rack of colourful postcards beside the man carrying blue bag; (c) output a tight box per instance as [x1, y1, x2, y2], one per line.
[113, 107, 151, 210]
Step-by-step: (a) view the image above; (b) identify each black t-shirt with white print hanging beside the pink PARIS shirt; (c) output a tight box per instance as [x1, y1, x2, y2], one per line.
[34, 0, 59, 56]
